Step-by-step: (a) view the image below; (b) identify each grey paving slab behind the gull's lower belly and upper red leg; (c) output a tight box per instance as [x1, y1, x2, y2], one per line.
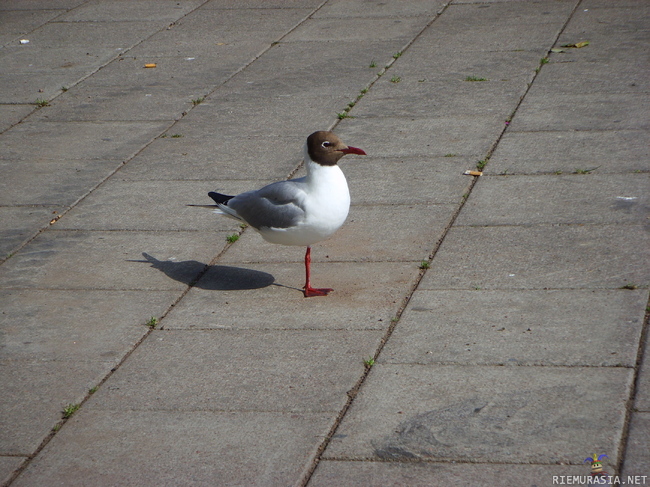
[222, 205, 454, 263]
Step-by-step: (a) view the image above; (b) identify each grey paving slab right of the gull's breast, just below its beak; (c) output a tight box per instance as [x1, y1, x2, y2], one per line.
[342, 158, 476, 205]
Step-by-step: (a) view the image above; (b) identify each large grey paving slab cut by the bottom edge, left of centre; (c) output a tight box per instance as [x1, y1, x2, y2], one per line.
[13, 411, 332, 487]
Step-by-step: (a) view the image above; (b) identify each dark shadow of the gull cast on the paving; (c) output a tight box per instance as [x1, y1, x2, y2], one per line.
[129, 252, 275, 291]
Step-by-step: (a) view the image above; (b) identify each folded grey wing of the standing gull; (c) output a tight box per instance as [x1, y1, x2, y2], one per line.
[228, 181, 305, 229]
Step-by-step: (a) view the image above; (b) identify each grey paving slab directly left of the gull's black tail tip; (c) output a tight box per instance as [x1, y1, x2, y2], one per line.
[57, 176, 241, 233]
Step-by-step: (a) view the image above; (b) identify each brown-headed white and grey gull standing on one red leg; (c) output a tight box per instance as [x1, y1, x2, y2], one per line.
[208, 131, 366, 297]
